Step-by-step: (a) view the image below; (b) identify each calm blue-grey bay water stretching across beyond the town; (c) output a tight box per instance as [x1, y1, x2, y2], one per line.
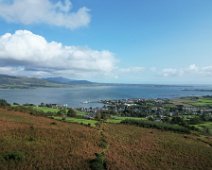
[0, 85, 212, 107]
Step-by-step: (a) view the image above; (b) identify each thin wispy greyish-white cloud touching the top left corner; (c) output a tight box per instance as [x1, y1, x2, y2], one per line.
[0, 0, 91, 29]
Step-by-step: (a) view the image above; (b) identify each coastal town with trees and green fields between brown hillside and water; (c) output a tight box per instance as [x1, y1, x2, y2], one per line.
[1, 96, 212, 135]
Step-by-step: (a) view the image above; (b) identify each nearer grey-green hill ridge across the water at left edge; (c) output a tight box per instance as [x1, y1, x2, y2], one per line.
[0, 74, 61, 88]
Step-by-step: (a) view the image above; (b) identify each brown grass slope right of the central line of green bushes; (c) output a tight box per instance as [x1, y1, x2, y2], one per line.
[105, 125, 212, 170]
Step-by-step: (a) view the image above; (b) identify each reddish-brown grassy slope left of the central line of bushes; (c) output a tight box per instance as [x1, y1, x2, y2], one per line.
[0, 109, 100, 170]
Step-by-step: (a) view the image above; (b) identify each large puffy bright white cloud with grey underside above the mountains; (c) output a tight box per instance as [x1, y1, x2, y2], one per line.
[0, 30, 116, 77]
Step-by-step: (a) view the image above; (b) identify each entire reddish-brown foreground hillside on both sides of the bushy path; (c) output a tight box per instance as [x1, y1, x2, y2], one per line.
[0, 109, 212, 170]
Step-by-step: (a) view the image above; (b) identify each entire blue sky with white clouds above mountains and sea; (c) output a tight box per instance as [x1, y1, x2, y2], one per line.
[0, 0, 212, 84]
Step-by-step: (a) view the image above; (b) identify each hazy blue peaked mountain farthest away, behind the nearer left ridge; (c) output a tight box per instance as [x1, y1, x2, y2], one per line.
[44, 77, 93, 85]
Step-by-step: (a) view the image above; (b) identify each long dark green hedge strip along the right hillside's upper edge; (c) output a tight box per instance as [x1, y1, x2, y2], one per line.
[121, 119, 190, 133]
